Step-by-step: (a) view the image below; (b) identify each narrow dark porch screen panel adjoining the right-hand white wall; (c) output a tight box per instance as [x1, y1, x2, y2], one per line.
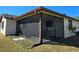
[54, 17, 64, 38]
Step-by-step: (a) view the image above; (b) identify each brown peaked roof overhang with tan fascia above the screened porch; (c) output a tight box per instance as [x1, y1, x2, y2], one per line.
[16, 7, 79, 21]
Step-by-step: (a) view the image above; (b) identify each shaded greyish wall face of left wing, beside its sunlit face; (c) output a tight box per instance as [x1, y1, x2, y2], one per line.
[6, 20, 16, 35]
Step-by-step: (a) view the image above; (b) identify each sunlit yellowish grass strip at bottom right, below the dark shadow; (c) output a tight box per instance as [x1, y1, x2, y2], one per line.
[29, 44, 79, 52]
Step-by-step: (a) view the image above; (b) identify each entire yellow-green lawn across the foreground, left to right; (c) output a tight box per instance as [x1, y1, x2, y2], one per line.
[0, 34, 79, 52]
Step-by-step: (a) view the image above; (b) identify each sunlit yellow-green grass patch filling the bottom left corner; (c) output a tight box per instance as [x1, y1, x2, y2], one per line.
[0, 34, 25, 51]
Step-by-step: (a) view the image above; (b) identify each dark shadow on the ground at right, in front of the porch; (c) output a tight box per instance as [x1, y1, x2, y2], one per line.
[44, 36, 79, 48]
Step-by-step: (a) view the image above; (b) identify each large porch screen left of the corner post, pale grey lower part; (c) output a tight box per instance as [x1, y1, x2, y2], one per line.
[20, 16, 39, 38]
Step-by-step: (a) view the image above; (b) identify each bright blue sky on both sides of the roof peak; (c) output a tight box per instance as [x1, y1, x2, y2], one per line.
[0, 6, 79, 17]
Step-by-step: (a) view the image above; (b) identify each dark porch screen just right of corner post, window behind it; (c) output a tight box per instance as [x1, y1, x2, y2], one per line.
[42, 14, 54, 36]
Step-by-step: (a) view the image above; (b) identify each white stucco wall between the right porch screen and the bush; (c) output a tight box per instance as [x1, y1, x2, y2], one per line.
[64, 18, 75, 38]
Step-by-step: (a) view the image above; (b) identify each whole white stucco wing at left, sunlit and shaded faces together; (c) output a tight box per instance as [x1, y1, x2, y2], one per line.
[0, 17, 16, 35]
